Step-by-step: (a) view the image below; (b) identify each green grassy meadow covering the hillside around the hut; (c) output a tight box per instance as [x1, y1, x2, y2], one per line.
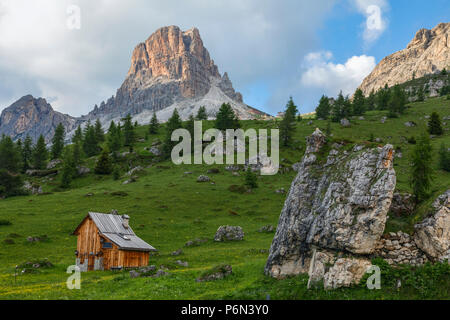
[0, 97, 450, 300]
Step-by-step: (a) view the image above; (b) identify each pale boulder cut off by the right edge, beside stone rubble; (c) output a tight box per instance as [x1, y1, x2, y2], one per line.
[414, 189, 450, 262]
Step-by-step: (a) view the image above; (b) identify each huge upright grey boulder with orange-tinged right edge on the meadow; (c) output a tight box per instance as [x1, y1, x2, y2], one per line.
[265, 130, 396, 278]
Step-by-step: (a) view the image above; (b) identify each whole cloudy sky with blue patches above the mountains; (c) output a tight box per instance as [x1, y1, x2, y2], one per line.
[0, 0, 450, 116]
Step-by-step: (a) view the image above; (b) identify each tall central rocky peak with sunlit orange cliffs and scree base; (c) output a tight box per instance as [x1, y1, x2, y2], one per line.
[83, 26, 265, 125]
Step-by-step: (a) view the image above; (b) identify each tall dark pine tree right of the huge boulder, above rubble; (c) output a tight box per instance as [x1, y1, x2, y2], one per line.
[410, 132, 433, 203]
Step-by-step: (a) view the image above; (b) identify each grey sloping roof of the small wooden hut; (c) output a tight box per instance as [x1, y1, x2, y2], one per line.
[85, 212, 156, 251]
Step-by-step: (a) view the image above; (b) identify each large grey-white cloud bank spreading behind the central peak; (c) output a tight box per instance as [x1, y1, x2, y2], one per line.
[0, 0, 335, 116]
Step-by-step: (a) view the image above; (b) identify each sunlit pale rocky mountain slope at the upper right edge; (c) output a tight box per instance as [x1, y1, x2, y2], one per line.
[360, 23, 450, 95]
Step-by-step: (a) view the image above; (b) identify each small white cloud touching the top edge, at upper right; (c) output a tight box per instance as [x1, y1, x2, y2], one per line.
[354, 0, 388, 44]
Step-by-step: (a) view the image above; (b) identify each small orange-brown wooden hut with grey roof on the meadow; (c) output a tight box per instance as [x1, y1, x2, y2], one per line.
[73, 212, 156, 272]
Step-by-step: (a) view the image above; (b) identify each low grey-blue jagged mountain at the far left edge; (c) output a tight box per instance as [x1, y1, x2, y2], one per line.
[0, 95, 77, 143]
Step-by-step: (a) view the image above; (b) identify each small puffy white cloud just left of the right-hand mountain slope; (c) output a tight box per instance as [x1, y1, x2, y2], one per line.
[300, 51, 376, 96]
